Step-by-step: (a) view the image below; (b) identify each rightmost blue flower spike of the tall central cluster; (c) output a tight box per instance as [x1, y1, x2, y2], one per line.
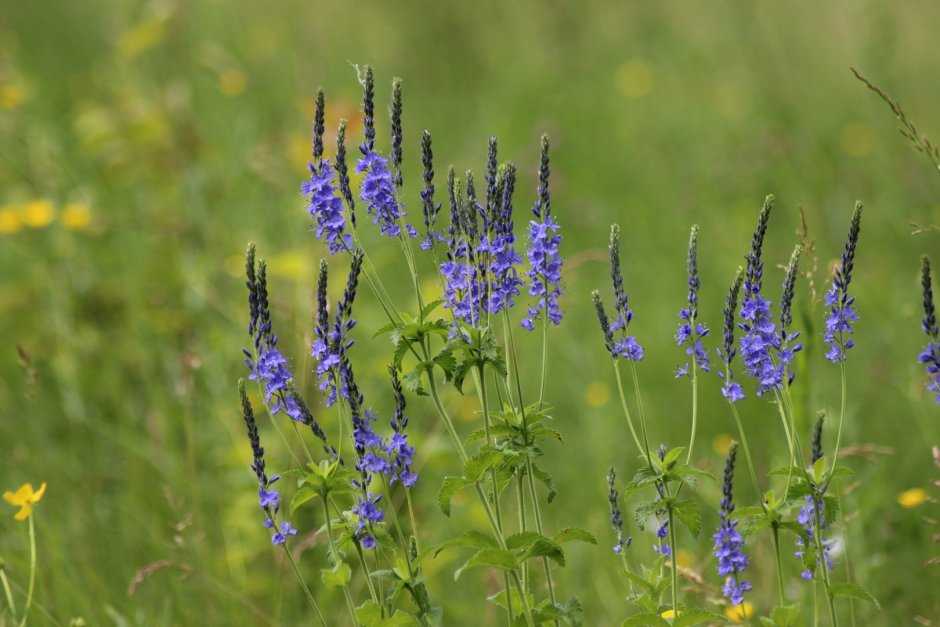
[522, 135, 564, 331]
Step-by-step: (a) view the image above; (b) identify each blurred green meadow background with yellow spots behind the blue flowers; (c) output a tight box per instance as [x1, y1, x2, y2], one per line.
[0, 0, 940, 625]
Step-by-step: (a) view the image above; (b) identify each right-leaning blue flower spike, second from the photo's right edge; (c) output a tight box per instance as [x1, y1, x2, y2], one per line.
[824, 202, 862, 363]
